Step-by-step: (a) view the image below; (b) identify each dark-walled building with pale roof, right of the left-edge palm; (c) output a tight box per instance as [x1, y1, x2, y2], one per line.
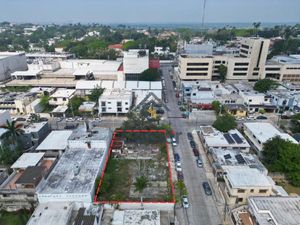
[20, 122, 50, 149]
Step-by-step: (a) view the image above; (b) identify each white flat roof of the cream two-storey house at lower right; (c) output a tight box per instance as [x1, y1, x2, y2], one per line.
[225, 166, 275, 188]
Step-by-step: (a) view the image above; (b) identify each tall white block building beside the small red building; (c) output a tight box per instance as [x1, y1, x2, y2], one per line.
[123, 49, 149, 80]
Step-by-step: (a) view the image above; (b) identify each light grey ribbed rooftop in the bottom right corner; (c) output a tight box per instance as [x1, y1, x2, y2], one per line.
[248, 197, 300, 225]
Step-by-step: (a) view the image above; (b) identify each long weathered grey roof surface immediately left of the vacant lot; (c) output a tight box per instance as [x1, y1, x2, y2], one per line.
[37, 149, 104, 195]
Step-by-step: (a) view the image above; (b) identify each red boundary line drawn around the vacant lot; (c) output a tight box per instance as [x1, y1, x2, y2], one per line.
[94, 130, 176, 204]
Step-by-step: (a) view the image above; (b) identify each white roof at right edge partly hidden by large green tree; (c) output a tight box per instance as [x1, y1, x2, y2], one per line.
[244, 122, 298, 144]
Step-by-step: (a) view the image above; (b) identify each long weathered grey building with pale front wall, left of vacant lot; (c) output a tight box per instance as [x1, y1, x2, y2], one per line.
[37, 149, 108, 205]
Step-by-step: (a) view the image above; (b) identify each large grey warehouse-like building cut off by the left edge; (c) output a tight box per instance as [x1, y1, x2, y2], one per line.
[0, 52, 27, 81]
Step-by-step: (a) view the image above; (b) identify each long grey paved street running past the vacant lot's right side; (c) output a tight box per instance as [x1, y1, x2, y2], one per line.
[161, 66, 221, 225]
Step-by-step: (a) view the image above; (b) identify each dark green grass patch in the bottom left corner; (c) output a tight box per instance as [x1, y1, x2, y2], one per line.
[0, 210, 31, 225]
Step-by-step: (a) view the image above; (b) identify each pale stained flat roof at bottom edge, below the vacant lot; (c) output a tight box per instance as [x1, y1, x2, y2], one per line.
[112, 210, 160, 225]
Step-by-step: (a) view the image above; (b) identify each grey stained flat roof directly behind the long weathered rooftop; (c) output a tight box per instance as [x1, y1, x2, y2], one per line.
[69, 124, 111, 141]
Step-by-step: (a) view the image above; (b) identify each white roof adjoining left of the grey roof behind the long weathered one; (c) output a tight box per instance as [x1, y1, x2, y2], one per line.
[36, 130, 72, 151]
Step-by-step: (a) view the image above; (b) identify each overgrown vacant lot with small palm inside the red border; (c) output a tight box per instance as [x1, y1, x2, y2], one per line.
[98, 130, 173, 202]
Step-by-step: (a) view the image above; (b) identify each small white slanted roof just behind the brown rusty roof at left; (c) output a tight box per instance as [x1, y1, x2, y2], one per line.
[10, 152, 45, 169]
